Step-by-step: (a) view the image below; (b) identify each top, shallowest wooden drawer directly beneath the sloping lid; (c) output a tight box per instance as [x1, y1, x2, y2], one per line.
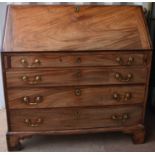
[11, 52, 146, 68]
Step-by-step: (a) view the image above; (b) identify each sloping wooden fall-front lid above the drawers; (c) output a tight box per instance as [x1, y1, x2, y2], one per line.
[3, 5, 151, 52]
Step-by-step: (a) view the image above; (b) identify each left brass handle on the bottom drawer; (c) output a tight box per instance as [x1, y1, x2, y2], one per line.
[24, 118, 43, 127]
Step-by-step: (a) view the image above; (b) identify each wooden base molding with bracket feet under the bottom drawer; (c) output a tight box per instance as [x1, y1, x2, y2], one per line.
[6, 124, 145, 151]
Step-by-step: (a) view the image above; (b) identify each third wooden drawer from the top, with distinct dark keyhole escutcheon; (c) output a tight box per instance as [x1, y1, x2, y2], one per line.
[8, 86, 145, 109]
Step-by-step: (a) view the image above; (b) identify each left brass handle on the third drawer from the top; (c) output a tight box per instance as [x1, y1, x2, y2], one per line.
[22, 96, 43, 105]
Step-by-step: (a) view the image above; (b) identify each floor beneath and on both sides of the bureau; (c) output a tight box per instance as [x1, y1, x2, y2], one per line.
[0, 110, 155, 152]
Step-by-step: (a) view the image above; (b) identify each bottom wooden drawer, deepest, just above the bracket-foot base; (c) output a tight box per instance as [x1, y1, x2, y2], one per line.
[10, 106, 142, 132]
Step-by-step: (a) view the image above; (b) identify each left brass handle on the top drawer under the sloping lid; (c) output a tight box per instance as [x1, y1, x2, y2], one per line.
[20, 58, 41, 68]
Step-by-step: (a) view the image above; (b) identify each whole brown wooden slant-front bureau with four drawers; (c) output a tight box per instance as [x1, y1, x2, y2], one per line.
[2, 5, 152, 150]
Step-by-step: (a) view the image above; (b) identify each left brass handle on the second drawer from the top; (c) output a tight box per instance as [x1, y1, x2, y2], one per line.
[21, 75, 42, 84]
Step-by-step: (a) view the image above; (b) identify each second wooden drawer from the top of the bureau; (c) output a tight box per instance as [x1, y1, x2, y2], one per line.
[6, 67, 147, 87]
